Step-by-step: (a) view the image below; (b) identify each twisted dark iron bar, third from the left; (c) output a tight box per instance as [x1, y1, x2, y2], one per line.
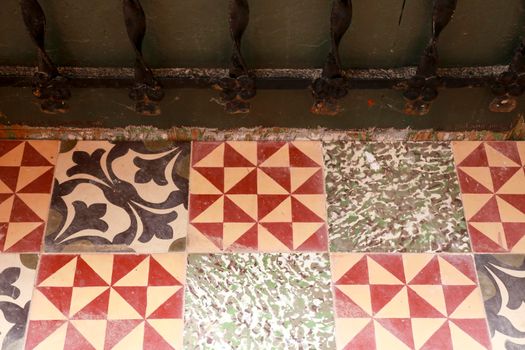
[214, 0, 256, 114]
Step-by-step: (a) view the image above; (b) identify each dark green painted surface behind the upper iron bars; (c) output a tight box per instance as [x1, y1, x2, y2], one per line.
[0, 0, 525, 68]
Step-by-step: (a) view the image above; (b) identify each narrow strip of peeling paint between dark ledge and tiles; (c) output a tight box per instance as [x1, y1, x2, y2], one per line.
[0, 121, 525, 141]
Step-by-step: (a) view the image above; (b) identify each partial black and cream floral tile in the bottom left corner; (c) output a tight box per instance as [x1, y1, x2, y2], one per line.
[0, 254, 38, 350]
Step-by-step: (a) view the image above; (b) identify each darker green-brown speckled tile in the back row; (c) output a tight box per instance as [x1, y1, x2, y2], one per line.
[325, 142, 470, 252]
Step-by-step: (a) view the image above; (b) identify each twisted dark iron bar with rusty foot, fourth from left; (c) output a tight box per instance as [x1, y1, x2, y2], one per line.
[310, 0, 352, 115]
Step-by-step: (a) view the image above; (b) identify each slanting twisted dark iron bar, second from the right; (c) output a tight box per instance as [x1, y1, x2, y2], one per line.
[403, 0, 457, 115]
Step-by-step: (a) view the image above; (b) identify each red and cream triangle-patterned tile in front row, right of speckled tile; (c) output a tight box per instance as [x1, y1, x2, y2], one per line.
[332, 253, 491, 350]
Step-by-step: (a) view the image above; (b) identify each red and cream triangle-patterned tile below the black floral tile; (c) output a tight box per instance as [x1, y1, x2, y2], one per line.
[26, 253, 186, 350]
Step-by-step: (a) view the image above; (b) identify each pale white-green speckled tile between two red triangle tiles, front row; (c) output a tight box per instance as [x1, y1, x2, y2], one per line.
[184, 253, 335, 350]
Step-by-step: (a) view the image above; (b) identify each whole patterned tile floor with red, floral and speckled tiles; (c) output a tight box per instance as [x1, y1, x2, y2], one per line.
[0, 141, 525, 350]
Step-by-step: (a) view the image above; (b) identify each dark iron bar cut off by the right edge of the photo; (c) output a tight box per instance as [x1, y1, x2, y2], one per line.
[489, 39, 525, 113]
